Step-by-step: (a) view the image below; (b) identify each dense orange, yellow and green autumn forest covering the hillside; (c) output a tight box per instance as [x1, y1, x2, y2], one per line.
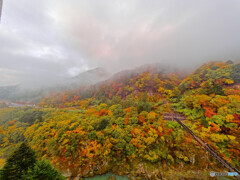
[0, 61, 240, 179]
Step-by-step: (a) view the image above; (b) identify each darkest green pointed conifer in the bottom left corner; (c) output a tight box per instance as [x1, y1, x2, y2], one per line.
[1, 143, 36, 180]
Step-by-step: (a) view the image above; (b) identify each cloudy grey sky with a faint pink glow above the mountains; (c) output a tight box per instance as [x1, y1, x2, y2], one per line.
[0, 0, 240, 86]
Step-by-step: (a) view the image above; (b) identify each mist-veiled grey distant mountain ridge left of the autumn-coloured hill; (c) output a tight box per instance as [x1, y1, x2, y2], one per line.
[0, 68, 110, 101]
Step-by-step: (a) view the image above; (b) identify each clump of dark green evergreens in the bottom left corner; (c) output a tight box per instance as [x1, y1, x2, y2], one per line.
[0, 143, 64, 180]
